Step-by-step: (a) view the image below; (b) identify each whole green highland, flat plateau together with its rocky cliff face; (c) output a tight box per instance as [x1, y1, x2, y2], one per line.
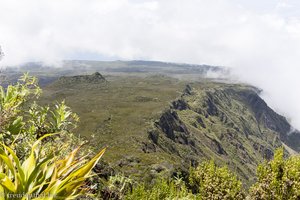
[36, 74, 300, 188]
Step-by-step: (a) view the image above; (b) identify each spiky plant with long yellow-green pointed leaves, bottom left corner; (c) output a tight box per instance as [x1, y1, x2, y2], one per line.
[0, 135, 105, 200]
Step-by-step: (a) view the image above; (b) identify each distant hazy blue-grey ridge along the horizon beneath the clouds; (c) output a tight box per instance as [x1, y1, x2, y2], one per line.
[3, 60, 229, 80]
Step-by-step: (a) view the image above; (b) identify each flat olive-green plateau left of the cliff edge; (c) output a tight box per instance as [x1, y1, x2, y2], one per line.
[38, 73, 185, 180]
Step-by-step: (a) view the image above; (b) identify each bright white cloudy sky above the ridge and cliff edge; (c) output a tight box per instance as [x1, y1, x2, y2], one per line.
[0, 0, 300, 129]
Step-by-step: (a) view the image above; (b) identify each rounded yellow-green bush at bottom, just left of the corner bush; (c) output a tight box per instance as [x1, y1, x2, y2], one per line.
[189, 161, 245, 200]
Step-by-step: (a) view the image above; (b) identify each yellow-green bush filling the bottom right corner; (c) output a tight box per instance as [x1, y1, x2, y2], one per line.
[250, 149, 300, 200]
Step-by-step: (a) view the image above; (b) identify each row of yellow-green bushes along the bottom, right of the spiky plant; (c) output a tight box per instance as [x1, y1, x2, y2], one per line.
[125, 153, 300, 200]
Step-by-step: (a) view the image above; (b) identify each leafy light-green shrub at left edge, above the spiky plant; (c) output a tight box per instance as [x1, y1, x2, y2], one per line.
[0, 74, 79, 153]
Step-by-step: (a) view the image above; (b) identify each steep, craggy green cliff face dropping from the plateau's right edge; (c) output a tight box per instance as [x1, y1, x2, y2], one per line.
[149, 83, 300, 182]
